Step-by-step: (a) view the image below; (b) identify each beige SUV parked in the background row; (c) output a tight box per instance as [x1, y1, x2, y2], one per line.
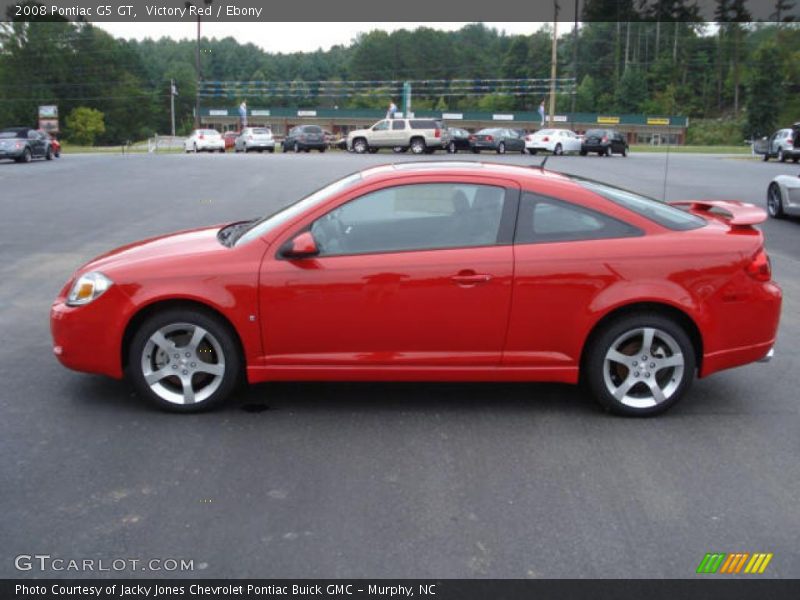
[347, 119, 450, 154]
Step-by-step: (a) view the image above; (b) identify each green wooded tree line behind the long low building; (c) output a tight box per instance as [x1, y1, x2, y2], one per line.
[0, 0, 800, 144]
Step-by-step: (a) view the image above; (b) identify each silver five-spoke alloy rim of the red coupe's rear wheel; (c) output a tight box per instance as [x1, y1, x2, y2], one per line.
[603, 327, 685, 408]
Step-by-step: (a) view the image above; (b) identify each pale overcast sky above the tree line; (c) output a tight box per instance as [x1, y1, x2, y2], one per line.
[94, 21, 548, 53]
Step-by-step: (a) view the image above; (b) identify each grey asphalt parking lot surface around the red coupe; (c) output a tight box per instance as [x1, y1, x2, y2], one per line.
[0, 153, 800, 578]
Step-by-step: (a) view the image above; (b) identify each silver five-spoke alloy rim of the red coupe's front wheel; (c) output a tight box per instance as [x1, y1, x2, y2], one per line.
[141, 323, 225, 404]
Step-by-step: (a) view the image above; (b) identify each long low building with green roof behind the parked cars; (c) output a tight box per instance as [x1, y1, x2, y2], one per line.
[200, 106, 689, 145]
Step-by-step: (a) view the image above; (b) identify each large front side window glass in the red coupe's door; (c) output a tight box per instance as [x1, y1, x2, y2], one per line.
[311, 183, 505, 256]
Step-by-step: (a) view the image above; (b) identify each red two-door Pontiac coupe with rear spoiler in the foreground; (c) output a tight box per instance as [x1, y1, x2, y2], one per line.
[51, 162, 781, 416]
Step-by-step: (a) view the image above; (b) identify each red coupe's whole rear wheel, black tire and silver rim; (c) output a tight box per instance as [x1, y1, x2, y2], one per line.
[582, 312, 696, 417]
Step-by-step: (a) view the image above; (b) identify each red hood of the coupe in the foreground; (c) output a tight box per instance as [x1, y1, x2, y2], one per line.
[78, 225, 230, 274]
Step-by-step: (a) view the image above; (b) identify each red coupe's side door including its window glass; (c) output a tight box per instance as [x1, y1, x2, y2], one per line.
[260, 181, 518, 367]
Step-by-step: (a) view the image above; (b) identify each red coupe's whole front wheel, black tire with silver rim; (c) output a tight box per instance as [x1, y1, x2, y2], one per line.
[128, 309, 242, 413]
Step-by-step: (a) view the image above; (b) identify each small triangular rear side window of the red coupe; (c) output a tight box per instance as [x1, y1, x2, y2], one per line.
[514, 193, 642, 244]
